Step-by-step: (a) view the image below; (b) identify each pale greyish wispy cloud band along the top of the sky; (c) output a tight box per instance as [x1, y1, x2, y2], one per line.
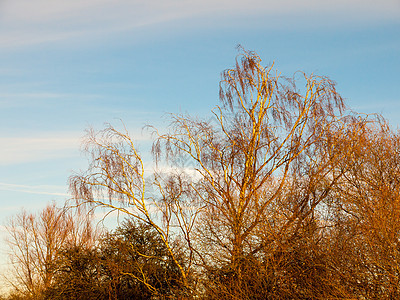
[0, 0, 400, 47]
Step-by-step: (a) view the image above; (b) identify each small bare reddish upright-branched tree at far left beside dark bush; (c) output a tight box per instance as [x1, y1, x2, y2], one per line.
[6, 203, 96, 299]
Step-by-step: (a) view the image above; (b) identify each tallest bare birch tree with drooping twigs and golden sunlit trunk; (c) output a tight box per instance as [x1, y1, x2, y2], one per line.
[153, 51, 356, 299]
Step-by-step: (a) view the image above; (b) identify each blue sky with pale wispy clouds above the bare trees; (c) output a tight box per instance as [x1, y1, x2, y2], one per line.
[0, 0, 400, 290]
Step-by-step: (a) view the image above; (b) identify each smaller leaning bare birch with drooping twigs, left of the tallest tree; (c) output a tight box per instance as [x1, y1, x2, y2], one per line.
[70, 126, 197, 295]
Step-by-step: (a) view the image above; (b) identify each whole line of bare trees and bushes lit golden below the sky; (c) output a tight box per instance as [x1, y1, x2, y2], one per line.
[1, 49, 400, 299]
